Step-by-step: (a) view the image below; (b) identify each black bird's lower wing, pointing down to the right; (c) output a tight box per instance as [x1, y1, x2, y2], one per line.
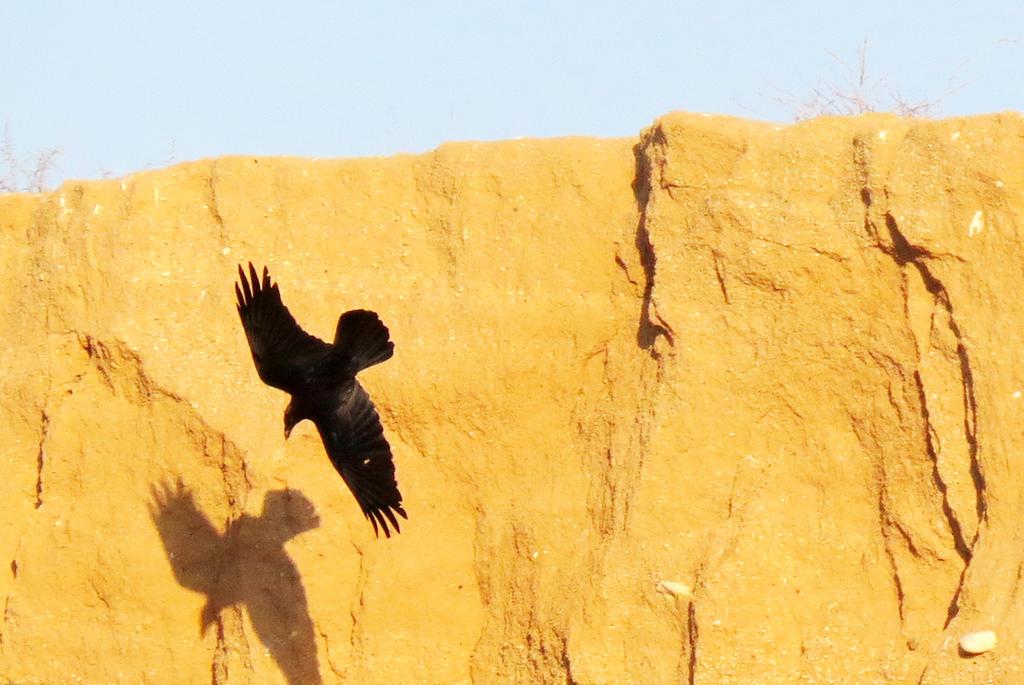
[317, 382, 409, 538]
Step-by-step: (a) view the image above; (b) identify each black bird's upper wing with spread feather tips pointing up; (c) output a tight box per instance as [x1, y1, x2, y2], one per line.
[234, 262, 331, 393]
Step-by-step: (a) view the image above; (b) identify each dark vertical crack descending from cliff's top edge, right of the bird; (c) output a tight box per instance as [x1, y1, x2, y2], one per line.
[633, 137, 676, 358]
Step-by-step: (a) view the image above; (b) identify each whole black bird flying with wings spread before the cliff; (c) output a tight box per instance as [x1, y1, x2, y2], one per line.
[234, 262, 409, 538]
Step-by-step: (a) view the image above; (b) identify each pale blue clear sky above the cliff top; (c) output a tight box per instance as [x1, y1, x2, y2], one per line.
[0, 0, 1024, 182]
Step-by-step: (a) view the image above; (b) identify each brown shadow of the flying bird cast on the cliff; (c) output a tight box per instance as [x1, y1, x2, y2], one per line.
[150, 479, 322, 685]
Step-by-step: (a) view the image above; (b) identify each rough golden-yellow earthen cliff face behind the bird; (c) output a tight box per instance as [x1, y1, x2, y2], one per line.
[0, 114, 1024, 685]
